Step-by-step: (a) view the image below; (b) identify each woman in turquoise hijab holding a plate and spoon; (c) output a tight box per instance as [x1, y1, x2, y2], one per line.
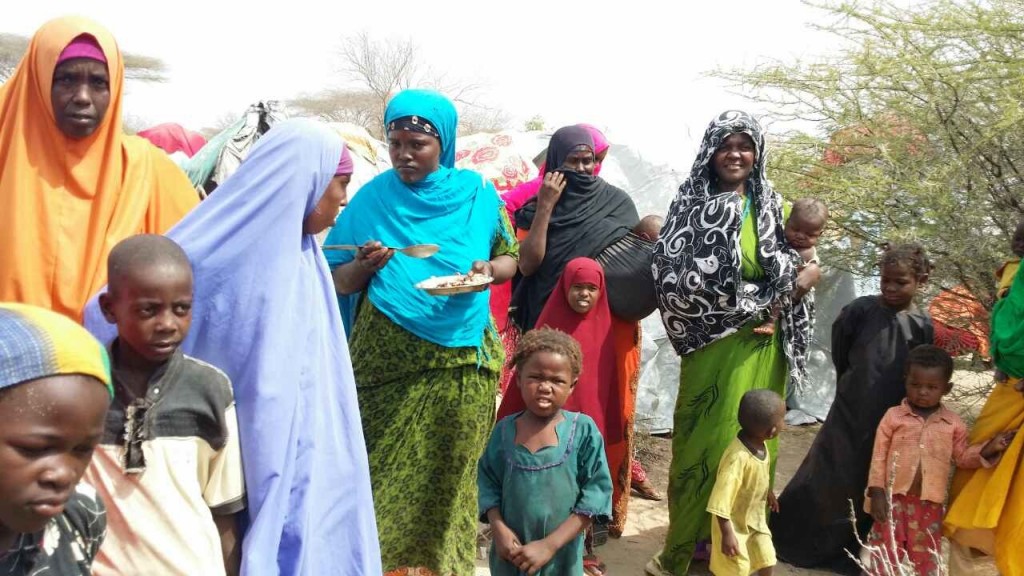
[326, 90, 519, 575]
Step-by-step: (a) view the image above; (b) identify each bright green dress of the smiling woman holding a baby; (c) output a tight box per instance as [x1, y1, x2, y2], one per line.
[659, 198, 788, 575]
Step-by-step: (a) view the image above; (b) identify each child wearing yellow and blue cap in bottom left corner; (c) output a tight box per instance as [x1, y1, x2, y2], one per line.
[0, 303, 113, 576]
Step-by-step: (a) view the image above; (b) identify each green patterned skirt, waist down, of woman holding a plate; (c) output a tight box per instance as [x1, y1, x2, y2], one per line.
[358, 366, 499, 575]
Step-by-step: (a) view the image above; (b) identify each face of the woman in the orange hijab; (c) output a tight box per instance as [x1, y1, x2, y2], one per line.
[50, 58, 111, 139]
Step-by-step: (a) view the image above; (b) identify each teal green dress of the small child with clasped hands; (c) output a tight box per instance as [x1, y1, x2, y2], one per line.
[477, 410, 611, 576]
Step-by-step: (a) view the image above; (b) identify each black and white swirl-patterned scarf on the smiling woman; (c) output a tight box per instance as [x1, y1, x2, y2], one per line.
[652, 111, 811, 385]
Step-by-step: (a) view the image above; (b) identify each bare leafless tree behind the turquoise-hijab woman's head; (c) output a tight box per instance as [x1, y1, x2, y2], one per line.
[289, 31, 509, 138]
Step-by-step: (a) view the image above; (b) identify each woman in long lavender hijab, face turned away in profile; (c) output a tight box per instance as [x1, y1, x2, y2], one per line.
[86, 120, 382, 576]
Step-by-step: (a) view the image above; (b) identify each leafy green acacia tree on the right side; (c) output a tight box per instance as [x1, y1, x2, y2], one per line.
[714, 0, 1024, 304]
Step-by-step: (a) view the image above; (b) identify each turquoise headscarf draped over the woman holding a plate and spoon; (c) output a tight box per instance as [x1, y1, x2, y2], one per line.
[326, 90, 511, 348]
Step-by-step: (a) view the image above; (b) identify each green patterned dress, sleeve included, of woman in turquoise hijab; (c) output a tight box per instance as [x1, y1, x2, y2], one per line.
[349, 208, 519, 576]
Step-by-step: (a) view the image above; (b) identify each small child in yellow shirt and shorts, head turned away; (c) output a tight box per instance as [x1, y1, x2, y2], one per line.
[708, 389, 785, 576]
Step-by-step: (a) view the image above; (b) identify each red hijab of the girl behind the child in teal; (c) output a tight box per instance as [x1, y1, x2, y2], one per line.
[498, 258, 626, 445]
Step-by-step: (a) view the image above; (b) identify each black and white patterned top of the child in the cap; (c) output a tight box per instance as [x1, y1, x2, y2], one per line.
[0, 484, 106, 576]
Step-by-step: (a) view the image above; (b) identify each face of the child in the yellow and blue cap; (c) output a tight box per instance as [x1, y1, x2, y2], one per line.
[0, 374, 111, 549]
